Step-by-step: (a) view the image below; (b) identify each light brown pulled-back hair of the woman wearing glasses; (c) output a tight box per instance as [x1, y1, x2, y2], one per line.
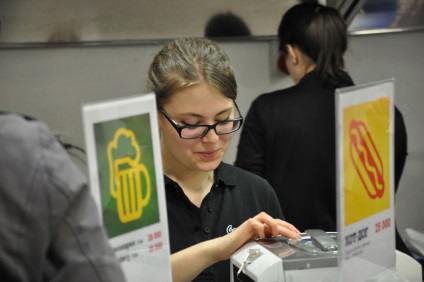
[147, 38, 237, 108]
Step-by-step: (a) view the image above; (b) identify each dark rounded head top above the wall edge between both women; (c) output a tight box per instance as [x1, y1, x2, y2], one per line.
[205, 12, 251, 37]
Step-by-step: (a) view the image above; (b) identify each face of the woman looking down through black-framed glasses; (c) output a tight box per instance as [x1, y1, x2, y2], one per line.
[159, 83, 235, 174]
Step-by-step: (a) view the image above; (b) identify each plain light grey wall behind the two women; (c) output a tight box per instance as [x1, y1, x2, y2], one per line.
[0, 31, 424, 243]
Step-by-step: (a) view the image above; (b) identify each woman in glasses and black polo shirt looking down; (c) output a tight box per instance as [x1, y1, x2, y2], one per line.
[148, 38, 299, 282]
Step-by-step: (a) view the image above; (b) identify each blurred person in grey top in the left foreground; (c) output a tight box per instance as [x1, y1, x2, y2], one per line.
[0, 113, 125, 282]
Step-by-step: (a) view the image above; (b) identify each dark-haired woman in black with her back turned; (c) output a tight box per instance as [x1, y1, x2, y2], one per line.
[234, 0, 407, 253]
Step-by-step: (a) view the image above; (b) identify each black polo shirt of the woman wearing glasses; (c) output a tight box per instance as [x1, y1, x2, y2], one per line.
[165, 163, 284, 282]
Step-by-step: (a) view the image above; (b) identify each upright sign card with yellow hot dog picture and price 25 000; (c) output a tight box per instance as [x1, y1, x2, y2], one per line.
[336, 79, 395, 281]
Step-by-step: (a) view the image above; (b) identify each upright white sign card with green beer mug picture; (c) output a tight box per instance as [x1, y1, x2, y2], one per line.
[82, 93, 172, 281]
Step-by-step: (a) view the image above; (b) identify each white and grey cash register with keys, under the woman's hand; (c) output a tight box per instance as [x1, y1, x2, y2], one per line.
[230, 229, 338, 282]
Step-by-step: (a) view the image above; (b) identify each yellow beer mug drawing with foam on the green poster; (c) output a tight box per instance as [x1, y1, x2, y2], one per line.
[107, 128, 152, 223]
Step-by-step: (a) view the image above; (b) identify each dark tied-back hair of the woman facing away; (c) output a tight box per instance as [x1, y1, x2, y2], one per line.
[278, 3, 347, 86]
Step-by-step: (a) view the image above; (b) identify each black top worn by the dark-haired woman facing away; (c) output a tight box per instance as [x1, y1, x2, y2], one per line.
[235, 72, 407, 232]
